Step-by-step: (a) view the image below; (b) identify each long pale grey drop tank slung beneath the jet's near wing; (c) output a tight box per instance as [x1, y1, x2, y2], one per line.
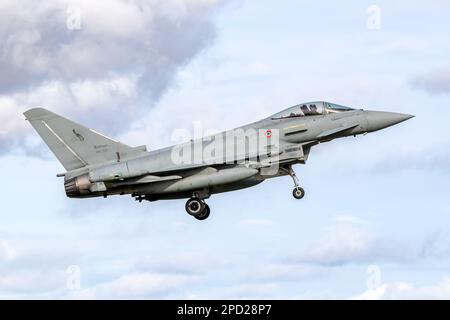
[140, 167, 259, 193]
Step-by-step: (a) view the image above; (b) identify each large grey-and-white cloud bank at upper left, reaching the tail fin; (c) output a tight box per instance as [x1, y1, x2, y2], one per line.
[0, 0, 222, 151]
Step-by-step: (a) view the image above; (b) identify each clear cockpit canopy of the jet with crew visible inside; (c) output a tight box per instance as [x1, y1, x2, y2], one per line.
[270, 101, 354, 119]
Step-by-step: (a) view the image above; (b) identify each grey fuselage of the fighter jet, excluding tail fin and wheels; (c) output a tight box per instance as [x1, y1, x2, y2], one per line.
[60, 102, 412, 201]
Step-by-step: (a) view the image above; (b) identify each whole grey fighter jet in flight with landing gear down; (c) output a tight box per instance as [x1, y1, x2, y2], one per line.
[24, 101, 413, 220]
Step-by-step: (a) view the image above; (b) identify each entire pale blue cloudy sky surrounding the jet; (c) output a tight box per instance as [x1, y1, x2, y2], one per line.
[0, 0, 450, 299]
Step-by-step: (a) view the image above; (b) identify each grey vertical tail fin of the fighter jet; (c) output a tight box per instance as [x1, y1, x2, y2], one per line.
[24, 108, 146, 171]
